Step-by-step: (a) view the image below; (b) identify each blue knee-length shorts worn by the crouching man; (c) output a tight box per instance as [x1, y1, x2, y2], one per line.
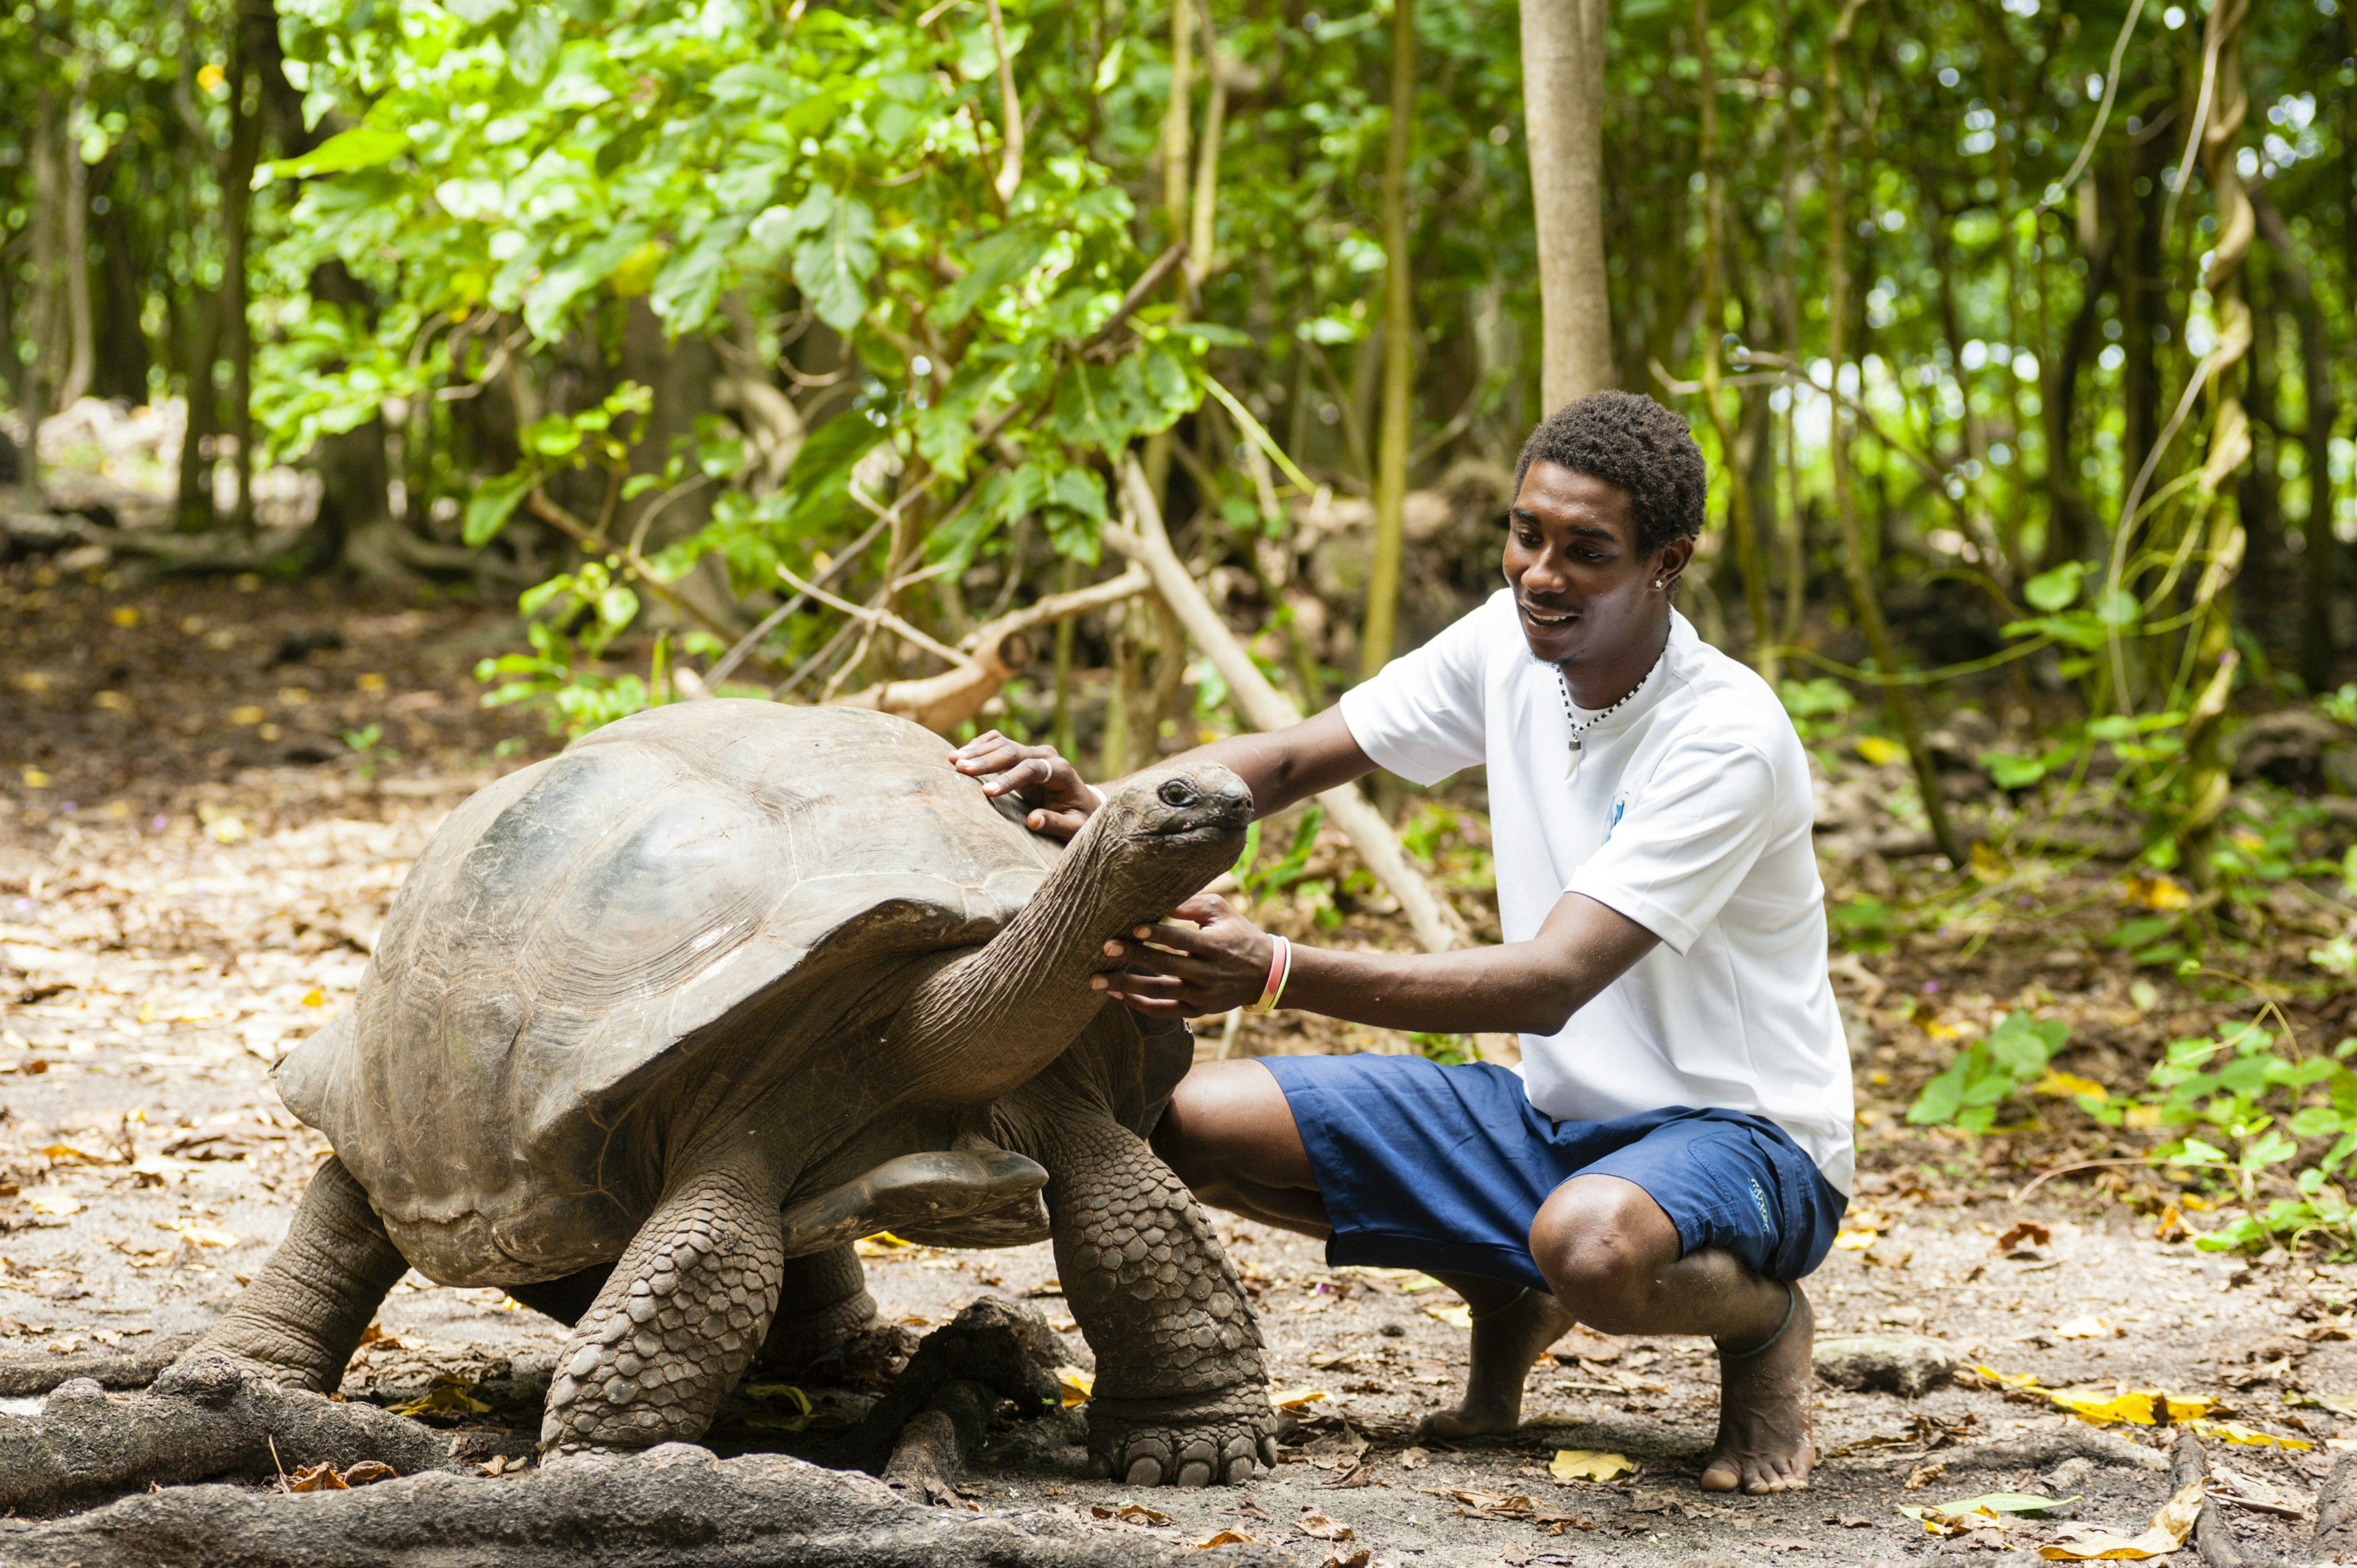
[1259, 1056, 1850, 1290]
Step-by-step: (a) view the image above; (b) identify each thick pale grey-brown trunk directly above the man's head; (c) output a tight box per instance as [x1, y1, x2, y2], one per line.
[1523, 0, 1612, 412]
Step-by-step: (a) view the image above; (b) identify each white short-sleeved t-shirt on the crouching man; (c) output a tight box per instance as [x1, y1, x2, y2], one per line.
[1341, 590, 1852, 1193]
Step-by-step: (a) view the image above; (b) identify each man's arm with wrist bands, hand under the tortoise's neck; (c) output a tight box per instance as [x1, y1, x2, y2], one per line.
[1091, 894, 1659, 1035]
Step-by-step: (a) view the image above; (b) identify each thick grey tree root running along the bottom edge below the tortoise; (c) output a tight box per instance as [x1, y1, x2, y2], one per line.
[0, 1443, 1291, 1568]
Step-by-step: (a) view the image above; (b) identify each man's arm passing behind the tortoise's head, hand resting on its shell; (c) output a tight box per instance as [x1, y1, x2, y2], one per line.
[954, 708, 1374, 840]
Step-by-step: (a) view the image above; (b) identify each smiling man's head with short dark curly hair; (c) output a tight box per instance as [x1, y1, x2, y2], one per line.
[1504, 392, 1709, 665]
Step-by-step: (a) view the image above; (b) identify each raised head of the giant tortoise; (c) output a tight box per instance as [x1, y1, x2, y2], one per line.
[1072, 762, 1252, 927]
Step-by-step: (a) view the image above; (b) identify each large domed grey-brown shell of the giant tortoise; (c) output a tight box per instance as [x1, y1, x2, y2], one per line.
[278, 700, 1061, 1283]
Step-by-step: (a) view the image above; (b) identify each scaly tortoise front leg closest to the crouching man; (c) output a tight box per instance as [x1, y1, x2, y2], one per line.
[1002, 1073, 1277, 1486]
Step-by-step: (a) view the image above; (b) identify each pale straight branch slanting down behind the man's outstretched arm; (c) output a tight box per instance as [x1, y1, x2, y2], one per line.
[1103, 453, 1471, 952]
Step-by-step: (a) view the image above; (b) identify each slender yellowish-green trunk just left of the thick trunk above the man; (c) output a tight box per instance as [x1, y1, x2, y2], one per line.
[1358, 0, 1417, 681]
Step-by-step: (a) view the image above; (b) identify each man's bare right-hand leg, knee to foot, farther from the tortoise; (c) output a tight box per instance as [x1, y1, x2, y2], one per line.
[1530, 1176, 1817, 1493]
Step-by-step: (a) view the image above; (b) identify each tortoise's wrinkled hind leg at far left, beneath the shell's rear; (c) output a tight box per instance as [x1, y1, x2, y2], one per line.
[177, 1156, 410, 1394]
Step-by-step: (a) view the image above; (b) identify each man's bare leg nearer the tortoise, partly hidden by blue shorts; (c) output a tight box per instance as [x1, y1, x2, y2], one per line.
[1155, 1061, 1572, 1439]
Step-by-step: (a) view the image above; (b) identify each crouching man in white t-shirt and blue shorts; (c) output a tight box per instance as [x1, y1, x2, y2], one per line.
[957, 392, 1850, 1493]
